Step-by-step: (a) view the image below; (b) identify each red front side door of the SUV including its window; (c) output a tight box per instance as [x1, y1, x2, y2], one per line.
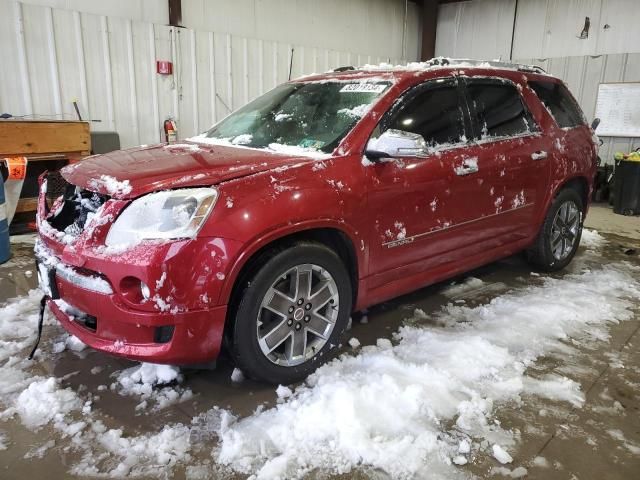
[365, 77, 486, 289]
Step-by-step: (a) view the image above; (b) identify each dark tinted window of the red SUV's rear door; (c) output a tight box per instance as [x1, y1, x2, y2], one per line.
[467, 80, 537, 138]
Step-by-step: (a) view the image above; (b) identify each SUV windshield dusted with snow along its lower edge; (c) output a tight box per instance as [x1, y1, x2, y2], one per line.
[194, 81, 389, 153]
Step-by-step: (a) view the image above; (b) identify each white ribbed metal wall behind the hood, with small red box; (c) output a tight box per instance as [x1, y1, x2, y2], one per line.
[0, 0, 410, 147]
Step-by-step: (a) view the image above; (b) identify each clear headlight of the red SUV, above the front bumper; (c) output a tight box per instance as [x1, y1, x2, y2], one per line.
[105, 188, 218, 247]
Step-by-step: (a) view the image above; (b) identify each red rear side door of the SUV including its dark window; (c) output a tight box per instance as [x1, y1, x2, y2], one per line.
[462, 77, 552, 246]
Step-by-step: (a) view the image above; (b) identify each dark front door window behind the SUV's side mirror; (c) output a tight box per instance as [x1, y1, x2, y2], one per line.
[387, 85, 466, 146]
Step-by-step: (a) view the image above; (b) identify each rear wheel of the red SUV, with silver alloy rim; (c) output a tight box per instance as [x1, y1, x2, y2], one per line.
[527, 188, 584, 272]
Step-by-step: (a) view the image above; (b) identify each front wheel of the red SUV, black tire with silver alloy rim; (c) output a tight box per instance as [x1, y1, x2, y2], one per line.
[231, 242, 352, 385]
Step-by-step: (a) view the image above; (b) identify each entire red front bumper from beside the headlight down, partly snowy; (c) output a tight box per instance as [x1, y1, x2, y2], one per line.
[35, 172, 235, 365]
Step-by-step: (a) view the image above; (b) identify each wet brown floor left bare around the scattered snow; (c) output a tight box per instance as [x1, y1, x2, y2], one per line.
[0, 206, 640, 480]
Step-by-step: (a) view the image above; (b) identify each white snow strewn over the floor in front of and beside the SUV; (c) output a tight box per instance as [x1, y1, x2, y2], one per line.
[0, 232, 640, 479]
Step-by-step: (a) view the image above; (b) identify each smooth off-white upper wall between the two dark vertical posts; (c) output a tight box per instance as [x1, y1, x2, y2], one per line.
[182, 0, 420, 60]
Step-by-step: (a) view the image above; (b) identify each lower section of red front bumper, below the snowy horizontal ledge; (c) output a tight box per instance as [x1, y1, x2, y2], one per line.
[36, 241, 227, 365]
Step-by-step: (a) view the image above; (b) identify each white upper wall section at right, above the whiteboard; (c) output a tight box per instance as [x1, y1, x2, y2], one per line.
[436, 0, 640, 60]
